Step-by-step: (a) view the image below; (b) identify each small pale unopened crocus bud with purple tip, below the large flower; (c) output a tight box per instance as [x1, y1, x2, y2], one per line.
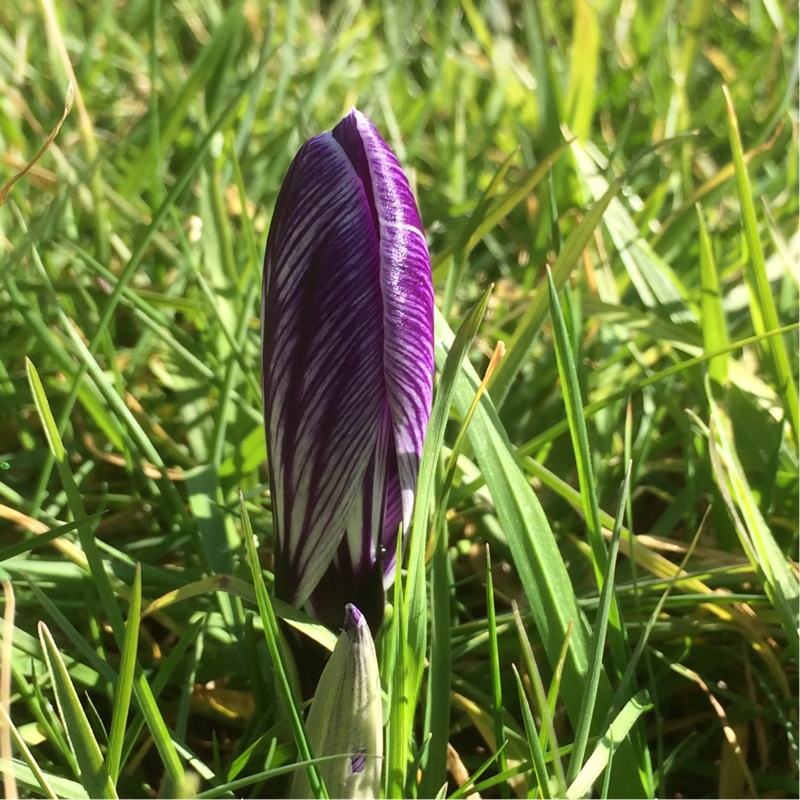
[291, 604, 383, 797]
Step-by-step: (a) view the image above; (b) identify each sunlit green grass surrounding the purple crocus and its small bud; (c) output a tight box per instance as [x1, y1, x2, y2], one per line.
[0, 0, 800, 797]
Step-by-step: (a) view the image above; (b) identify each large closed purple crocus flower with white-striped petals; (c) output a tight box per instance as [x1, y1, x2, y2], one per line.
[261, 109, 433, 631]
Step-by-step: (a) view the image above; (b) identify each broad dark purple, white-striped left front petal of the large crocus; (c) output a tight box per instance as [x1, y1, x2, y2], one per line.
[262, 133, 386, 605]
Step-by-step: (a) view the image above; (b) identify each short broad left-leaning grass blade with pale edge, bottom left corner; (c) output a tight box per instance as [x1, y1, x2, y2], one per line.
[39, 622, 117, 798]
